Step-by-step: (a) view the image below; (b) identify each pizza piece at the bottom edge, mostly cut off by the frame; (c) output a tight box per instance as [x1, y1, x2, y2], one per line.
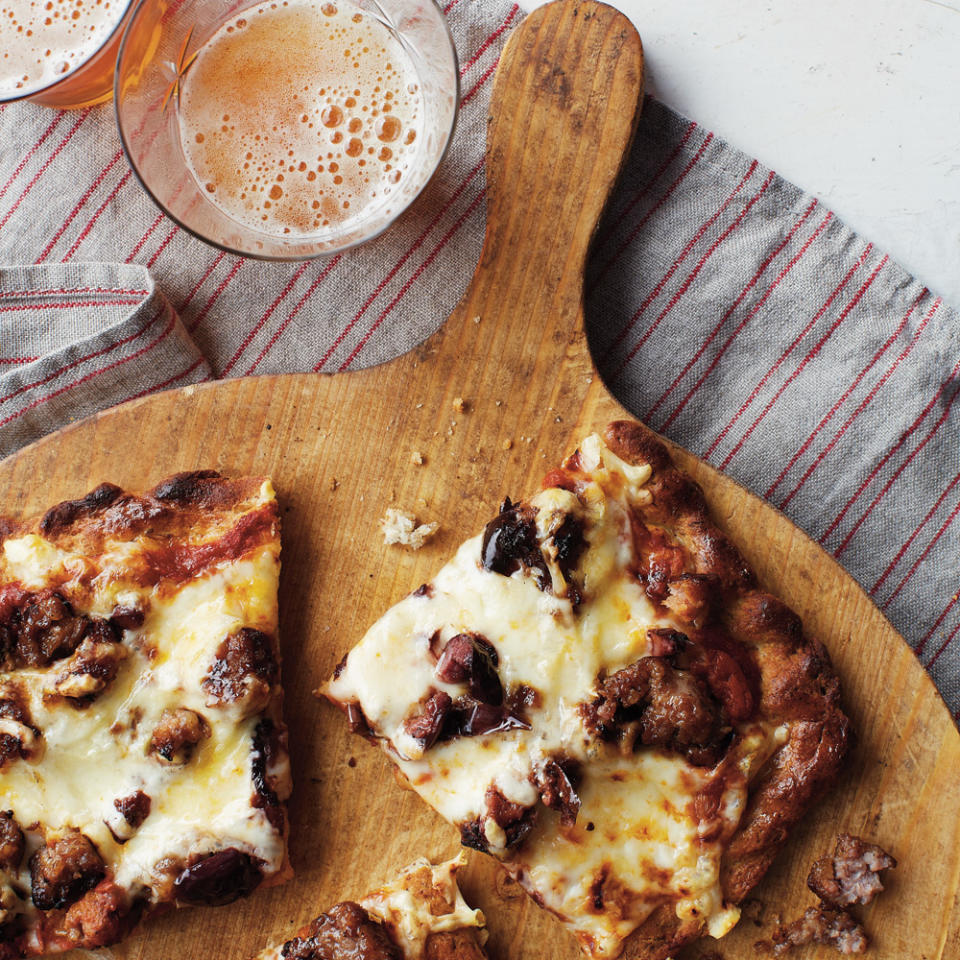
[256, 854, 486, 960]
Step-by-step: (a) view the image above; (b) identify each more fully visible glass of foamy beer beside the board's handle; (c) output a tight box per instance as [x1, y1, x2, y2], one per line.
[115, 0, 459, 260]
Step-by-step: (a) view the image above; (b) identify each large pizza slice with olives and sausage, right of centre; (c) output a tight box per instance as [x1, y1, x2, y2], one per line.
[323, 421, 849, 960]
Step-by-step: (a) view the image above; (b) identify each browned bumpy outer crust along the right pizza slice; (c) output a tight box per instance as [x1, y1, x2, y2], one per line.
[603, 420, 852, 960]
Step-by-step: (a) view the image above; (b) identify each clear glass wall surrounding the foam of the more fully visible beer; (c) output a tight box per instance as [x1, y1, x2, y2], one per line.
[115, 0, 459, 260]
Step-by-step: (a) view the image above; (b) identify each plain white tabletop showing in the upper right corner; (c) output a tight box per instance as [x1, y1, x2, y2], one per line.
[520, 0, 960, 307]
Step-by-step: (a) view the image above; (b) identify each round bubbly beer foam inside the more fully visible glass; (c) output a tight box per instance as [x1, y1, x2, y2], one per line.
[180, 0, 424, 238]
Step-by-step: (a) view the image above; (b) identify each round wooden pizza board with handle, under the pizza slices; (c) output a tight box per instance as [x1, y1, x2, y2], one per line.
[0, 0, 960, 960]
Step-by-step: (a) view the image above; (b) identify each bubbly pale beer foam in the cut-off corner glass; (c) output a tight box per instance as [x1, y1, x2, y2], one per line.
[0, 0, 128, 100]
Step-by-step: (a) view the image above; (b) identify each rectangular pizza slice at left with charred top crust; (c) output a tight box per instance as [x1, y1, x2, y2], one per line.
[0, 472, 290, 960]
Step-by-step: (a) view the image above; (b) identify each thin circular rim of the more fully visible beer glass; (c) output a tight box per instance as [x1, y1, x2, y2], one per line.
[113, 0, 460, 263]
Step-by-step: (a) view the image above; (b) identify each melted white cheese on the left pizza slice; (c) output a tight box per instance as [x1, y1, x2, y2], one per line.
[0, 484, 286, 928]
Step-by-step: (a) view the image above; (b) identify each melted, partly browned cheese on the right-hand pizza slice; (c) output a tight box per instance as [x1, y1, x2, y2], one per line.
[326, 437, 777, 958]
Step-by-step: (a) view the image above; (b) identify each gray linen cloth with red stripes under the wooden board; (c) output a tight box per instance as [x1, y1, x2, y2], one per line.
[0, 0, 960, 716]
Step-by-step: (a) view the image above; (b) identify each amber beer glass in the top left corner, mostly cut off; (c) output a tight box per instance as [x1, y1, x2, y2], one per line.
[0, 0, 133, 109]
